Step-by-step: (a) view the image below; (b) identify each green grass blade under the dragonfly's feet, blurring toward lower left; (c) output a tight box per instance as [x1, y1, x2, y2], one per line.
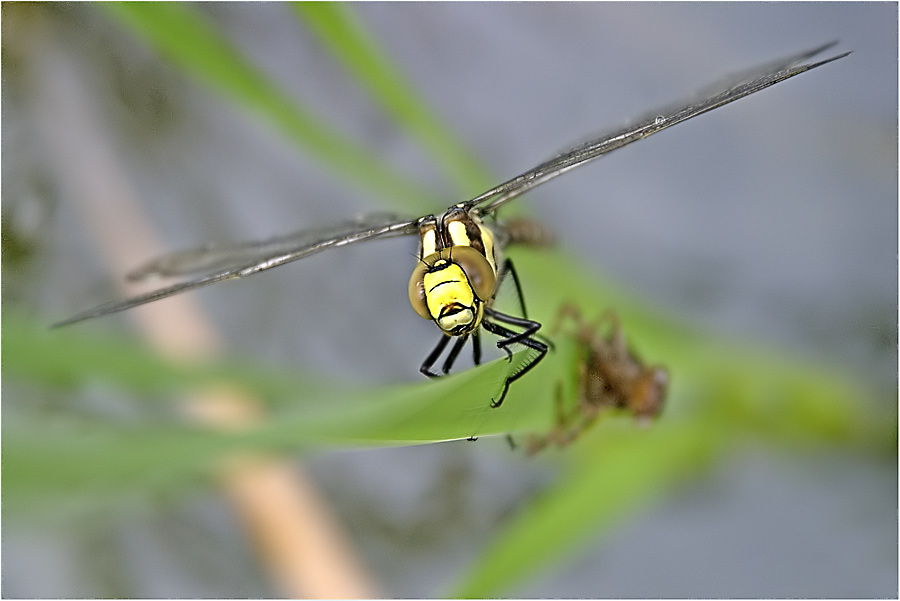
[2, 342, 551, 518]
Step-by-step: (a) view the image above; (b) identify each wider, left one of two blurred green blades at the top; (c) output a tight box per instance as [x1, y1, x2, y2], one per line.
[103, 2, 441, 210]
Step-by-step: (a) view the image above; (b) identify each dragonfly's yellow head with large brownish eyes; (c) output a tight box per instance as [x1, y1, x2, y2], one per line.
[409, 245, 497, 336]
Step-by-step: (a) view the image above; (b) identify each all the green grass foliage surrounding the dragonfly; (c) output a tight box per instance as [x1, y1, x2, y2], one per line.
[3, 3, 896, 597]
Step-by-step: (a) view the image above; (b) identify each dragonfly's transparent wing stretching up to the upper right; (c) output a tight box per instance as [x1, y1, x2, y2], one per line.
[463, 42, 850, 213]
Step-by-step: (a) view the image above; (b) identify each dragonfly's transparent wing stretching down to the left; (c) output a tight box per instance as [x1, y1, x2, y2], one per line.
[53, 213, 418, 327]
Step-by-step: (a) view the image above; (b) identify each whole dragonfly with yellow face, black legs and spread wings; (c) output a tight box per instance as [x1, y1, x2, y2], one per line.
[54, 42, 850, 407]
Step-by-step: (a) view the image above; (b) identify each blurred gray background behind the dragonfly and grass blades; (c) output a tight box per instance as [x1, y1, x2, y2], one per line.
[2, 3, 897, 597]
